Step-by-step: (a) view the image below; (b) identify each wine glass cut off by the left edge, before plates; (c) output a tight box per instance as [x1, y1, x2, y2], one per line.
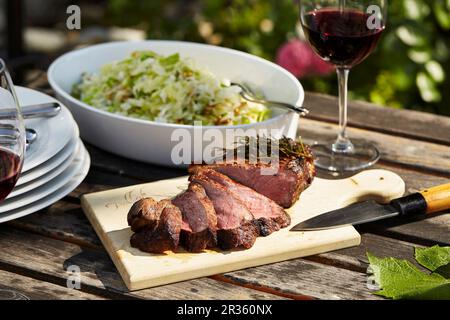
[0, 59, 25, 202]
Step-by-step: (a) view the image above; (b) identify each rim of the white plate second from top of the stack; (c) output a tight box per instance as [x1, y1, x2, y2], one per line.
[16, 132, 79, 187]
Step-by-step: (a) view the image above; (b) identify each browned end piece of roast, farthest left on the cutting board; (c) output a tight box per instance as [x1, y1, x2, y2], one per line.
[128, 198, 182, 253]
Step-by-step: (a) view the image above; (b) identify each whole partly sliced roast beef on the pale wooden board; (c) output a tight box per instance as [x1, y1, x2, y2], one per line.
[127, 138, 315, 253]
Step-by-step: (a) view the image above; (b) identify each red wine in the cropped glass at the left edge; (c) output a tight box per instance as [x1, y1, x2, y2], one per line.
[0, 149, 22, 201]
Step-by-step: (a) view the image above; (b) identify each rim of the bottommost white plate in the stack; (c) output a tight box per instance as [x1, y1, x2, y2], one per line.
[0, 142, 91, 223]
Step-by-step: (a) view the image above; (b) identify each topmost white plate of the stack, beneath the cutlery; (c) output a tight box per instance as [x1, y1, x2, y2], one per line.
[16, 87, 78, 172]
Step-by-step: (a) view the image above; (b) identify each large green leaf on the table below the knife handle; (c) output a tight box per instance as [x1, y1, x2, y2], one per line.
[367, 252, 450, 300]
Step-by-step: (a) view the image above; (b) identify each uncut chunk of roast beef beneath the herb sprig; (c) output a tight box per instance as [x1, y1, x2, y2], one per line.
[189, 158, 315, 208]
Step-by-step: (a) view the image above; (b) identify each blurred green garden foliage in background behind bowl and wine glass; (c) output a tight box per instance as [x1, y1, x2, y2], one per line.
[108, 0, 450, 115]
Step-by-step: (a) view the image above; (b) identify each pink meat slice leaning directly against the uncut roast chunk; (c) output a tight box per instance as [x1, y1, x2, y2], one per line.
[199, 170, 291, 236]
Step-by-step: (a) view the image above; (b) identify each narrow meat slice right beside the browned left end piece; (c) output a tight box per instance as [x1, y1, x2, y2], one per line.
[172, 182, 217, 252]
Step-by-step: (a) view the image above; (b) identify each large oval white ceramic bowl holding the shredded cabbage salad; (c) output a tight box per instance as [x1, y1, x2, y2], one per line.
[48, 40, 304, 166]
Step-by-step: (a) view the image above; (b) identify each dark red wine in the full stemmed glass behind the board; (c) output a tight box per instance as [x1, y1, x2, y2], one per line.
[303, 8, 384, 68]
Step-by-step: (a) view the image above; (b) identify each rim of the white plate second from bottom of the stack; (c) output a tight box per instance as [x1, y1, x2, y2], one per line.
[0, 142, 87, 213]
